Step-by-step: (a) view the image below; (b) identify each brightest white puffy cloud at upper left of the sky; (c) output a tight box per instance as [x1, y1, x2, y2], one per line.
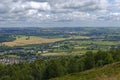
[11, 1, 50, 11]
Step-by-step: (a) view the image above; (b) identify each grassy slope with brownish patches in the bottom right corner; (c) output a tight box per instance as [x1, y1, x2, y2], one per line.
[51, 62, 120, 80]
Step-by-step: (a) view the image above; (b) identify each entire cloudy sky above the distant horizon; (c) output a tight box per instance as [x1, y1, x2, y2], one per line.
[0, 0, 120, 27]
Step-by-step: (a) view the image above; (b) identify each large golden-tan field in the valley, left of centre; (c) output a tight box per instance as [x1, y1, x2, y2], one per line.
[3, 36, 65, 47]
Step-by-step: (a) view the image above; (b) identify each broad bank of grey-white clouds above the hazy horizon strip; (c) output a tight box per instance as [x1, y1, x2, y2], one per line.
[0, 0, 120, 27]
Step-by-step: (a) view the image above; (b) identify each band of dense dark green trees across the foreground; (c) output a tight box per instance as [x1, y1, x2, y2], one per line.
[0, 49, 120, 80]
